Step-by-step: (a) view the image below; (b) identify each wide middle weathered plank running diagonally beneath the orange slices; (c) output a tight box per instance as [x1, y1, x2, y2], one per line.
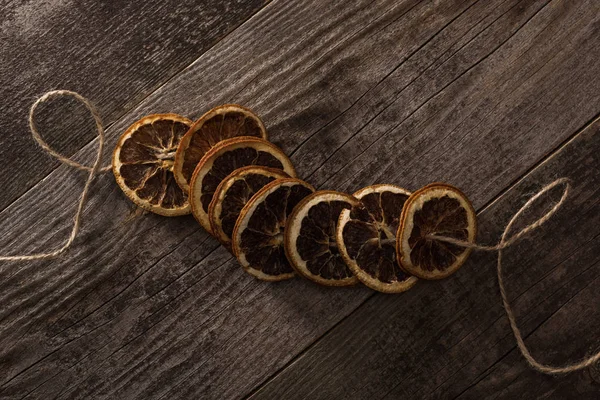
[0, 0, 600, 398]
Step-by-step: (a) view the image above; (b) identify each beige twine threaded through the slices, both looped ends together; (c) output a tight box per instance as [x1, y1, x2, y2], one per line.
[0, 90, 600, 375]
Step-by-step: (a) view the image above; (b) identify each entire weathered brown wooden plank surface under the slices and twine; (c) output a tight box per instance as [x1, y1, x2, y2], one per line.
[0, 0, 600, 399]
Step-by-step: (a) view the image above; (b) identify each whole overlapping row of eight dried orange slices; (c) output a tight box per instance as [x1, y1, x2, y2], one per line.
[113, 104, 476, 293]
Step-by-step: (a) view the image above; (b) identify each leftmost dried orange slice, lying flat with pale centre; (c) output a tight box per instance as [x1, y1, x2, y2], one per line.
[112, 114, 192, 217]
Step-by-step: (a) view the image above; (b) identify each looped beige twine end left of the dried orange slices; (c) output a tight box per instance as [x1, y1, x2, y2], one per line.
[0, 90, 111, 261]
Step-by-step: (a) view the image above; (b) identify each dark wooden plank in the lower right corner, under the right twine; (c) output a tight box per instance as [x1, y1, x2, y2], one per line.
[252, 121, 600, 399]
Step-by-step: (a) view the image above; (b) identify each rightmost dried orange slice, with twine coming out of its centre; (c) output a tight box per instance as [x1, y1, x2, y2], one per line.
[396, 183, 477, 279]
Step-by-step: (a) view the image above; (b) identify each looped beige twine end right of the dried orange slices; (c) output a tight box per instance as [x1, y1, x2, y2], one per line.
[429, 178, 600, 375]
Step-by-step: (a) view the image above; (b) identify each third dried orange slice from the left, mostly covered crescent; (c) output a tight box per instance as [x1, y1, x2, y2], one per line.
[189, 136, 296, 233]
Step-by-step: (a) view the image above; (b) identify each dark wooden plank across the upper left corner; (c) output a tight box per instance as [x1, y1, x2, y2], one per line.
[0, 0, 264, 209]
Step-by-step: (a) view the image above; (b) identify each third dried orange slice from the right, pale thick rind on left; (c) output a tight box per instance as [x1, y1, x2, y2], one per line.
[284, 190, 359, 286]
